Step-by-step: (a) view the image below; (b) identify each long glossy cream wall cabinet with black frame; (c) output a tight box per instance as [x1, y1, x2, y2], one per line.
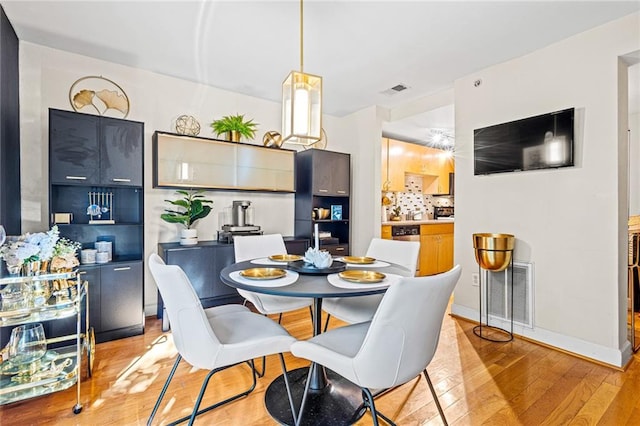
[153, 131, 295, 192]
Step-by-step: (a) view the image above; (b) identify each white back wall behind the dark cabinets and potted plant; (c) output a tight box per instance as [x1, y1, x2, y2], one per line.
[20, 42, 352, 315]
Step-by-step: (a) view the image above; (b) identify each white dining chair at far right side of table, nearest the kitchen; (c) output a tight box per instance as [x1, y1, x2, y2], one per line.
[322, 238, 420, 330]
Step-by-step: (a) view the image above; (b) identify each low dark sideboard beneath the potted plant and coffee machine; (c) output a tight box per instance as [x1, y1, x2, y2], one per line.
[157, 237, 309, 318]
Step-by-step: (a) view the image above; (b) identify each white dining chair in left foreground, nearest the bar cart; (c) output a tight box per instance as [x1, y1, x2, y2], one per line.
[147, 254, 296, 425]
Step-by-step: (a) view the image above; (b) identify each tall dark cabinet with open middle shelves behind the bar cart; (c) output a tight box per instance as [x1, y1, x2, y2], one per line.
[49, 109, 144, 342]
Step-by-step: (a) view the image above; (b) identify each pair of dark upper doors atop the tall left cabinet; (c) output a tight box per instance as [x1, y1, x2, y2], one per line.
[49, 109, 144, 187]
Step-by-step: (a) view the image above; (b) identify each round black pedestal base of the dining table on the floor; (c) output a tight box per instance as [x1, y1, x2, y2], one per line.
[265, 367, 366, 426]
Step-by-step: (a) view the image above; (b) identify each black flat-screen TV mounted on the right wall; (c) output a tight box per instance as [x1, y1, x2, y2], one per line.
[473, 108, 574, 175]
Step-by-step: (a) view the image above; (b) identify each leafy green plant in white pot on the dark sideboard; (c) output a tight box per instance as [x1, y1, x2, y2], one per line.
[160, 190, 213, 246]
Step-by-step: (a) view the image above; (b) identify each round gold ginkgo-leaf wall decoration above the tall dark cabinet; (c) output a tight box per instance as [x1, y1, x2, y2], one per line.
[69, 75, 129, 118]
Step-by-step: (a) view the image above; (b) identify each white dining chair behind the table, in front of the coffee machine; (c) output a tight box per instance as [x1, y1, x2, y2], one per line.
[233, 234, 313, 322]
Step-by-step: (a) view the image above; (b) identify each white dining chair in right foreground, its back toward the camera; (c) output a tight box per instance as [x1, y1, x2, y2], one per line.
[291, 265, 462, 425]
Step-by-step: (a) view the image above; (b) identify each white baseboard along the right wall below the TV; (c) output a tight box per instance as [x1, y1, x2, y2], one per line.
[451, 303, 633, 369]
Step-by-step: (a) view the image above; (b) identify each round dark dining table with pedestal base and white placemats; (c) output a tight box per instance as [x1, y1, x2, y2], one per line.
[220, 258, 412, 426]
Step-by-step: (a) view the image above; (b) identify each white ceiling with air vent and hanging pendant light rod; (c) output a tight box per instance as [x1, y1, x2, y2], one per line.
[0, 0, 640, 145]
